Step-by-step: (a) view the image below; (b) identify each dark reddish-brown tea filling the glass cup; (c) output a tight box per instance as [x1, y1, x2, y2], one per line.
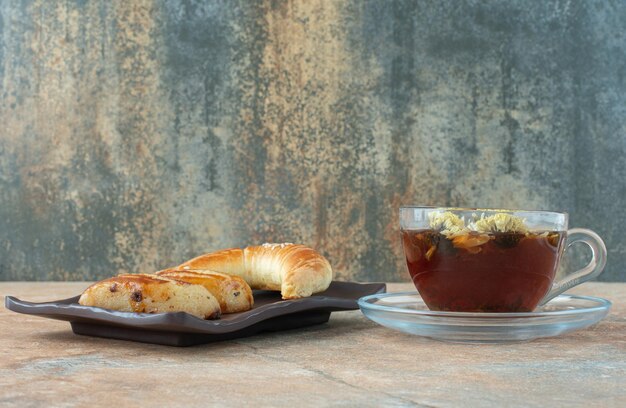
[402, 230, 565, 312]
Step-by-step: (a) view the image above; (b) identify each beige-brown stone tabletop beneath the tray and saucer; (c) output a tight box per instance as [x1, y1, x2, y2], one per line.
[0, 282, 626, 407]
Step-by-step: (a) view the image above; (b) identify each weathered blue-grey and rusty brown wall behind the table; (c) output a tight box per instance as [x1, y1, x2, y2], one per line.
[0, 0, 626, 280]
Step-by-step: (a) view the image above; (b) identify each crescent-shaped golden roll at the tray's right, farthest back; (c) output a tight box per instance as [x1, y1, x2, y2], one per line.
[177, 244, 333, 299]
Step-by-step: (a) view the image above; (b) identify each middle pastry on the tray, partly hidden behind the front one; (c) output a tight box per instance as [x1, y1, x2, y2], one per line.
[157, 269, 254, 313]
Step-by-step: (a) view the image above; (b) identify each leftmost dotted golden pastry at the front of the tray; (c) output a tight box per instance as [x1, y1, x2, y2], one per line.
[78, 274, 221, 319]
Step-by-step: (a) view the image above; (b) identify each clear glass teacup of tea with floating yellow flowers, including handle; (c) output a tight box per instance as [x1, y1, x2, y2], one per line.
[400, 206, 606, 313]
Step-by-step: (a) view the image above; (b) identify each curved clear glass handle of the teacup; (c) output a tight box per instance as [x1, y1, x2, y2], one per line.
[541, 228, 606, 305]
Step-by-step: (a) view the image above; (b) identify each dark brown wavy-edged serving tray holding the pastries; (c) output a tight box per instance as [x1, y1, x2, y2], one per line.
[5, 281, 386, 346]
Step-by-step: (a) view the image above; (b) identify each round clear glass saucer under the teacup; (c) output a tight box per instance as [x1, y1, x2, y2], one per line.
[359, 292, 611, 343]
